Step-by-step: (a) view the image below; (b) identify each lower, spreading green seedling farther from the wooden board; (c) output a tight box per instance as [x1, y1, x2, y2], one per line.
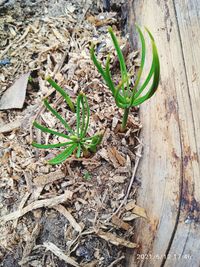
[32, 78, 102, 164]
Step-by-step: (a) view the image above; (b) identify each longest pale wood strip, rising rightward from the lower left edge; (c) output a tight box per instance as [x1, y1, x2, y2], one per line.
[0, 191, 73, 222]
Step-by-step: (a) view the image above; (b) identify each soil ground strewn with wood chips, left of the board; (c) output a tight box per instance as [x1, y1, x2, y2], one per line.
[0, 0, 146, 267]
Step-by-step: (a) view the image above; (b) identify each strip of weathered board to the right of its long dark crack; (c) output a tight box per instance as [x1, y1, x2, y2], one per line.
[166, 0, 200, 267]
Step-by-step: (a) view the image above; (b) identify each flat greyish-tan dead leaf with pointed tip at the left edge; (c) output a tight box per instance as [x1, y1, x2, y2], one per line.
[0, 72, 30, 110]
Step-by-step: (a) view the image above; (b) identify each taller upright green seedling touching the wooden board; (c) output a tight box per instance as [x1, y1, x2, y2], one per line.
[90, 26, 160, 131]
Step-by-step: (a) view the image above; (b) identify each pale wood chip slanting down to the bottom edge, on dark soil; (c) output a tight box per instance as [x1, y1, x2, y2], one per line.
[43, 242, 80, 267]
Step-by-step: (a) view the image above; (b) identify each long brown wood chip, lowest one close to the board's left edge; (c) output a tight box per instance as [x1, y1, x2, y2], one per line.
[96, 230, 138, 248]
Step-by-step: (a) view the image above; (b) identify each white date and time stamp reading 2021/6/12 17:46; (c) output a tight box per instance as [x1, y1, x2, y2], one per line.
[136, 253, 192, 261]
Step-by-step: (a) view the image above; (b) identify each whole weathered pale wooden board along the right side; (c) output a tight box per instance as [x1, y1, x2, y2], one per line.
[129, 0, 200, 267]
